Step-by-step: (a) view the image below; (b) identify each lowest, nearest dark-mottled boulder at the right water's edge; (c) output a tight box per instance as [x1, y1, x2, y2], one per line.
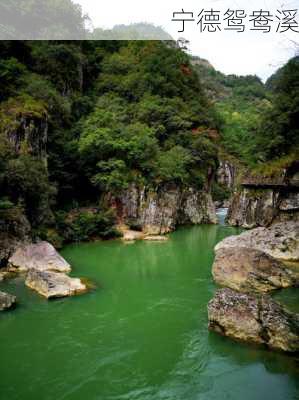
[208, 288, 299, 352]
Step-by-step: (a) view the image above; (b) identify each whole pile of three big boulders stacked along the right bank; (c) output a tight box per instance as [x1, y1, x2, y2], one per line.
[208, 217, 299, 352]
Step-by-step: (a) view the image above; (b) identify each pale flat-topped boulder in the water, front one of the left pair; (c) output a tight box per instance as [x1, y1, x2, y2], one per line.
[25, 269, 87, 299]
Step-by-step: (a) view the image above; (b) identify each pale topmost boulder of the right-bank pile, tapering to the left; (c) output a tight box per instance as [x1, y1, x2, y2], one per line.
[215, 221, 299, 261]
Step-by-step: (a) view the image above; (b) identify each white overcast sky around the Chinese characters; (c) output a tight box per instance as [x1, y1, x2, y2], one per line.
[75, 0, 299, 81]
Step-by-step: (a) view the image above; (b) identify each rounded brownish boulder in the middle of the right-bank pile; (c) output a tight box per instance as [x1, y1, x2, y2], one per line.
[212, 247, 299, 293]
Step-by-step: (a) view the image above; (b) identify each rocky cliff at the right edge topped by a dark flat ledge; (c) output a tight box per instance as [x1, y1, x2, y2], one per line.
[227, 166, 299, 228]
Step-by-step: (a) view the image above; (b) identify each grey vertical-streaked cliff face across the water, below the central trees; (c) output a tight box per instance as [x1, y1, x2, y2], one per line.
[109, 185, 217, 235]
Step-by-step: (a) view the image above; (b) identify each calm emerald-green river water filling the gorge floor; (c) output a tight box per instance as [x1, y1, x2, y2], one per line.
[0, 225, 299, 400]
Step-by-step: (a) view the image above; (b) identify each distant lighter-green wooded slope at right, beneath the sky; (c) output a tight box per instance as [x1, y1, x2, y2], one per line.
[193, 57, 299, 173]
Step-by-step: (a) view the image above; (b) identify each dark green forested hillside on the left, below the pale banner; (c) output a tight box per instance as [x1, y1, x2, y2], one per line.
[0, 41, 219, 244]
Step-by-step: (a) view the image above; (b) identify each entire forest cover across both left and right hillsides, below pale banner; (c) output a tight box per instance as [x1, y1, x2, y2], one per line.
[0, 41, 299, 242]
